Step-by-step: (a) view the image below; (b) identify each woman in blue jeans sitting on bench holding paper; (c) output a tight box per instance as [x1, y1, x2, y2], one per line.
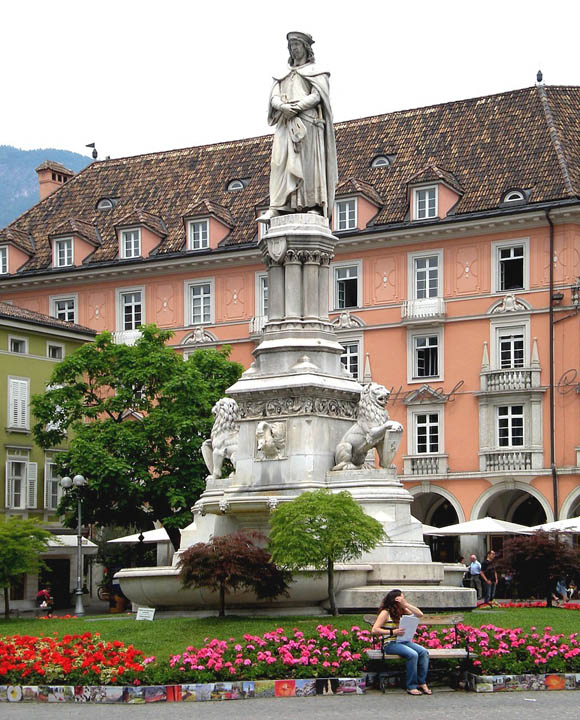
[372, 590, 432, 695]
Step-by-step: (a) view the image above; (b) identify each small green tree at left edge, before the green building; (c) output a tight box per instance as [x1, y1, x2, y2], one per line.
[0, 517, 52, 619]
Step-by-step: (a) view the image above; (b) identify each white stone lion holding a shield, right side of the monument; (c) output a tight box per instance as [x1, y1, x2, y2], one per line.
[332, 383, 403, 470]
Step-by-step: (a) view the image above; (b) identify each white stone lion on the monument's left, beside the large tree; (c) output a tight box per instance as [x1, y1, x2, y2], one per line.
[201, 398, 240, 481]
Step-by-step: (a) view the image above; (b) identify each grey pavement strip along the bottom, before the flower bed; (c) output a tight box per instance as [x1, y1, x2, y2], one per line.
[0, 689, 580, 720]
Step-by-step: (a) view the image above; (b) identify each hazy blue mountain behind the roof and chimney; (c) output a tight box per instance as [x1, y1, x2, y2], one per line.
[0, 145, 91, 228]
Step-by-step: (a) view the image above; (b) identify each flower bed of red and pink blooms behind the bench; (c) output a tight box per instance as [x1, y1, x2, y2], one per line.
[0, 624, 580, 695]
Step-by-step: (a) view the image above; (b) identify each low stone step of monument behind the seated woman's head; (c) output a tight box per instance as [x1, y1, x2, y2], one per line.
[322, 584, 477, 612]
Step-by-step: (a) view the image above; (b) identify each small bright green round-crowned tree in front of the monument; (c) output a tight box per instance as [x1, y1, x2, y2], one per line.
[269, 490, 386, 615]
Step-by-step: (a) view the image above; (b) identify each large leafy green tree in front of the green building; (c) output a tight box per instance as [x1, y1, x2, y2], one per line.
[32, 325, 243, 549]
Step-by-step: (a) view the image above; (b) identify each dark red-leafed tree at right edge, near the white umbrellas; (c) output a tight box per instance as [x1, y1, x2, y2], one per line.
[497, 530, 580, 607]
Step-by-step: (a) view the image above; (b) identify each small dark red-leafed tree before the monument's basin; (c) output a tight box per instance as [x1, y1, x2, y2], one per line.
[179, 530, 292, 617]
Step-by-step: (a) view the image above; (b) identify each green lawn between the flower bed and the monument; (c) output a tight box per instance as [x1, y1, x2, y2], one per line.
[0, 608, 580, 658]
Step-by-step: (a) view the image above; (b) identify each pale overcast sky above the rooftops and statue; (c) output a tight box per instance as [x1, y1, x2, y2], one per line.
[0, 0, 580, 159]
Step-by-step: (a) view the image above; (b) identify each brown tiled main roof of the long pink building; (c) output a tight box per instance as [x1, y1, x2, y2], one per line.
[4, 86, 580, 270]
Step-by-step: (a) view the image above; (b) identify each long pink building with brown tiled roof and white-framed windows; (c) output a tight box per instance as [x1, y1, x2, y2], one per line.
[0, 86, 580, 559]
